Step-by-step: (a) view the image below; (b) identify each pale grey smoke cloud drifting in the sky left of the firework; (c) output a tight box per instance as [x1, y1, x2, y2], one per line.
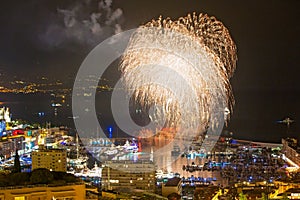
[39, 0, 123, 48]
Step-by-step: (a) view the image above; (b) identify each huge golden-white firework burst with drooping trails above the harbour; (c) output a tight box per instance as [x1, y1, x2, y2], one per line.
[120, 13, 237, 138]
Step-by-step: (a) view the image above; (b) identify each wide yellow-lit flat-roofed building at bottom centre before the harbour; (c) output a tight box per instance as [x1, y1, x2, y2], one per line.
[102, 161, 155, 192]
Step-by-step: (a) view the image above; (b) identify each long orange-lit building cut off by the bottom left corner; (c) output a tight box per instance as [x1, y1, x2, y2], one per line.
[0, 184, 85, 200]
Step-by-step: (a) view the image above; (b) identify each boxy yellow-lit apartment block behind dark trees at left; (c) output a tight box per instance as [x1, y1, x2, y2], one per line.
[31, 145, 67, 172]
